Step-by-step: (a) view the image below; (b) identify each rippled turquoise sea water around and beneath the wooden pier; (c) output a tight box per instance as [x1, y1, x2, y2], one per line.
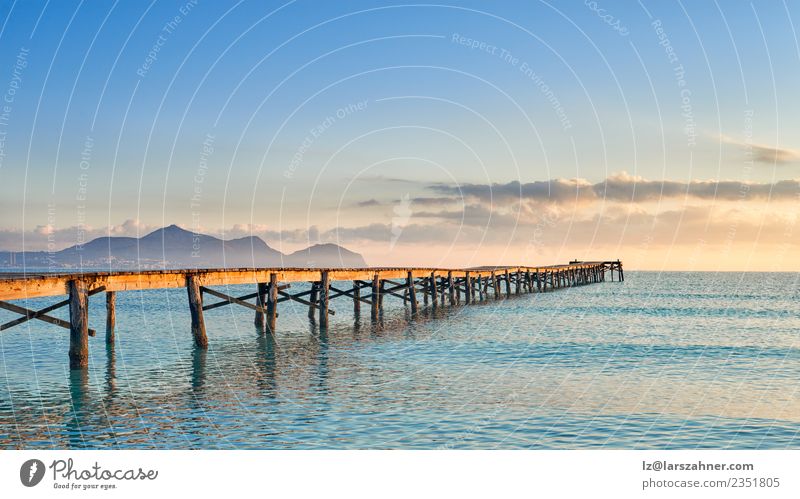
[0, 272, 800, 449]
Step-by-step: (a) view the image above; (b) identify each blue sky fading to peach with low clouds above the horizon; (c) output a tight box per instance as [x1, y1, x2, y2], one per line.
[0, 0, 800, 271]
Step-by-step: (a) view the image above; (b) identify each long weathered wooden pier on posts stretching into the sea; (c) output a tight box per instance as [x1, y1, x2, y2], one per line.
[0, 260, 624, 369]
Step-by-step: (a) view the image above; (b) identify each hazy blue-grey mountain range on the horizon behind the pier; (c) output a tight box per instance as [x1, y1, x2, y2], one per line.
[0, 225, 367, 270]
